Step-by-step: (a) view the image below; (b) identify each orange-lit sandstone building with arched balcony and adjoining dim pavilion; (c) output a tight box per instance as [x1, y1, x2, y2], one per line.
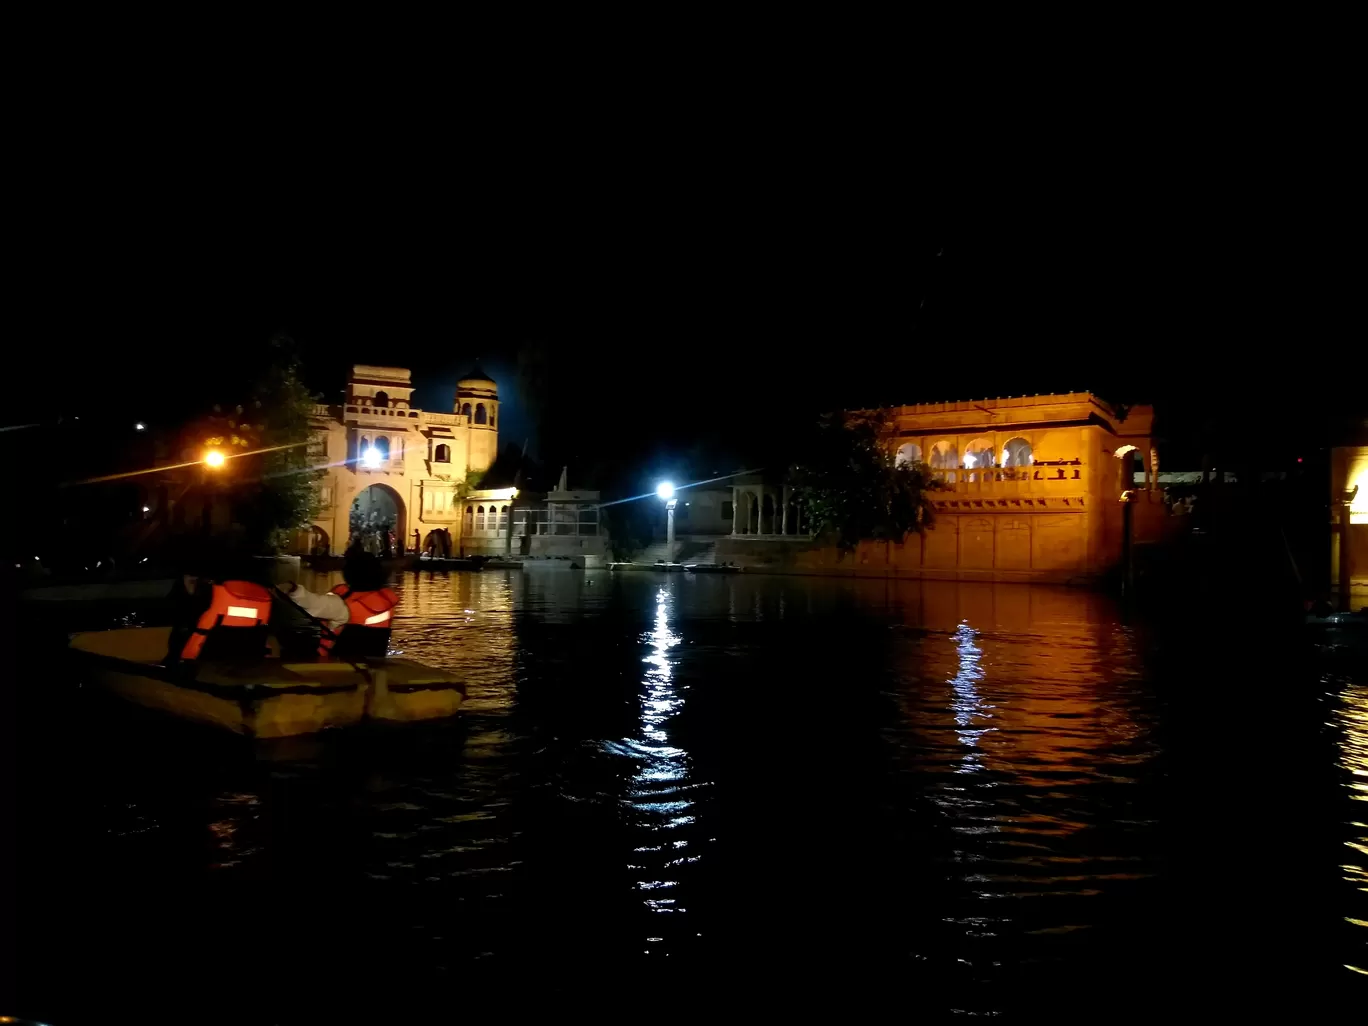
[718, 393, 1166, 581]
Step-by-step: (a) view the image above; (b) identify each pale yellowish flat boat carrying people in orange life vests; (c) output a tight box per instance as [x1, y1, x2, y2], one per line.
[70, 627, 465, 739]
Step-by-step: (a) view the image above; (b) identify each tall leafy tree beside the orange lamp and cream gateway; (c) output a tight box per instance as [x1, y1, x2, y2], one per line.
[207, 335, 323, 553]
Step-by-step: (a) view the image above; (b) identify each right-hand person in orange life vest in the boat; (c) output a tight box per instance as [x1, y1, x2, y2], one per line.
[276, 547, 399, 659]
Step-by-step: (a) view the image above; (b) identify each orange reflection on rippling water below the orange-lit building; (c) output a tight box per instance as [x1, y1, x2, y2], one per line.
[899, 583, 1153, 804]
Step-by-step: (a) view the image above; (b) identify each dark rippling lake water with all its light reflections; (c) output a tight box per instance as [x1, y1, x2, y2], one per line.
[10, 572, 1368, 1022]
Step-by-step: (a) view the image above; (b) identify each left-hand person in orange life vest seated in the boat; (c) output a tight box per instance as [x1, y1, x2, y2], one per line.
[166, 557, 272, 666]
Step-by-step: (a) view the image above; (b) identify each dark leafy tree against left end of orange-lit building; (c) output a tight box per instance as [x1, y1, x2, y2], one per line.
[789, 410, 943, 551]
